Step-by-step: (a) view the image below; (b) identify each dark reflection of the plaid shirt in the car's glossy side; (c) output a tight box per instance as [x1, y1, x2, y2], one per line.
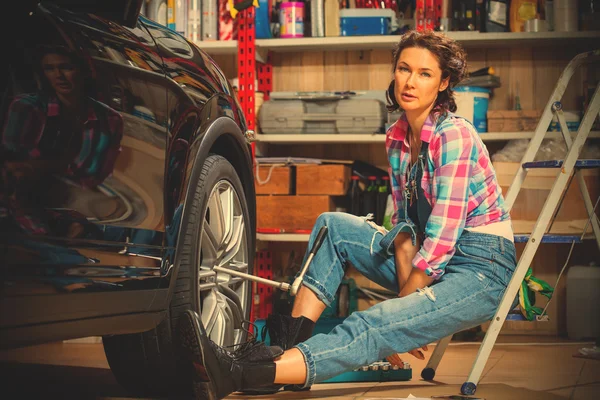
[0, 94, 123, 234]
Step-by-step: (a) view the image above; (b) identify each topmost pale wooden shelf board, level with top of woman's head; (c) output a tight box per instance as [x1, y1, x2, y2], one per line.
[196, 31, 600, 54]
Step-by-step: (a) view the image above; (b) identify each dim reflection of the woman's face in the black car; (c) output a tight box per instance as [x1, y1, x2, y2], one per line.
[42, 54, 80, 96]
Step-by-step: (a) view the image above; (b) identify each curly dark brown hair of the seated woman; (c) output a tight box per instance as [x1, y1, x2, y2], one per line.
[386, 30, 467, 114]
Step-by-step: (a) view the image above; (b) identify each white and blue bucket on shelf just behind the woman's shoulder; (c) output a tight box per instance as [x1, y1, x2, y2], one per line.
[454, 86, 491, 133]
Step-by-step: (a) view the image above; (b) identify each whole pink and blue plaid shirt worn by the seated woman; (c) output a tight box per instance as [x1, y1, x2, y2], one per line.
[386, 113, 510, 279]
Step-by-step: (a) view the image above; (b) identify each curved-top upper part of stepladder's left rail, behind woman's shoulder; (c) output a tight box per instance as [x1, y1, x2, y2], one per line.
[504, 50, 600, 211]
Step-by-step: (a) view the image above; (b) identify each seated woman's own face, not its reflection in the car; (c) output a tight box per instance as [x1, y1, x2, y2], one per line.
[394, 47, 448, 112]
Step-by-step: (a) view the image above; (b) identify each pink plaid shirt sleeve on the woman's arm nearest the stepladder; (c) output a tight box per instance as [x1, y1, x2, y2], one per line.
[413, 124, 477, 279]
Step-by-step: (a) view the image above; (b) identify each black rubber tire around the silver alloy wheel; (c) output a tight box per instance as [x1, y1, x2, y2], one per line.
[104, 154, 254, 396]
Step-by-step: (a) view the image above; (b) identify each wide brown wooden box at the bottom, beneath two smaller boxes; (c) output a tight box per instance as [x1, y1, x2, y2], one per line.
[256, 196, 335, 230]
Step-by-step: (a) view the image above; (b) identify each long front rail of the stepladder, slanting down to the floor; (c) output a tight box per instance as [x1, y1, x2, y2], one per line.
[467, 76, 600, 384]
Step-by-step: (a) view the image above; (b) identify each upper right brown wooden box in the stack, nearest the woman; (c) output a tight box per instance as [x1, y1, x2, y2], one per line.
[296, 164, 352, 196]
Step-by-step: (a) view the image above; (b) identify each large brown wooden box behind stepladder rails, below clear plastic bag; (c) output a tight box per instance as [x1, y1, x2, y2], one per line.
[493, 162, 600, 234]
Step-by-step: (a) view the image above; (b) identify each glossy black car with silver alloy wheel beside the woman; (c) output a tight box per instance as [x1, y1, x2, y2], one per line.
[0, 0, 256, 394]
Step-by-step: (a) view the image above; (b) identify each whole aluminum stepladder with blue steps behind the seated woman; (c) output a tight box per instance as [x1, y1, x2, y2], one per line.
[421, 50, 600, 395]
